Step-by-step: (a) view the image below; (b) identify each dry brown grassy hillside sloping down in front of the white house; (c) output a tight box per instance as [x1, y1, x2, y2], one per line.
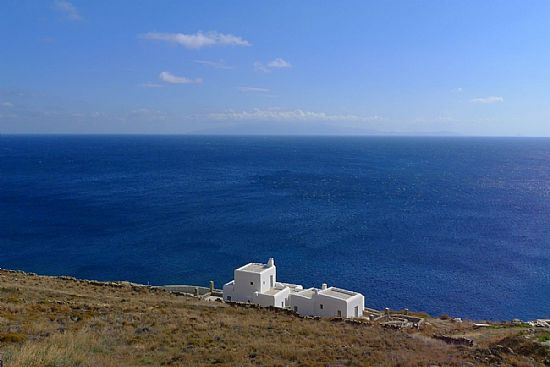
[0, 271, 550, 367]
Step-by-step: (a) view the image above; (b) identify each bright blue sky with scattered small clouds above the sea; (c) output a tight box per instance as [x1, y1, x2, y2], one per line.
[0, 0, 550, 136]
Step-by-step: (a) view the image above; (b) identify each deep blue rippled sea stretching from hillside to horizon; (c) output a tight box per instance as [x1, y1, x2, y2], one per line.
[0, 136, 550, 319]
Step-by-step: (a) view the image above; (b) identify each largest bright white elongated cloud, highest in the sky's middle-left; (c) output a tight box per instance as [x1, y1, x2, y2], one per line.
[141, 31, 250, 49]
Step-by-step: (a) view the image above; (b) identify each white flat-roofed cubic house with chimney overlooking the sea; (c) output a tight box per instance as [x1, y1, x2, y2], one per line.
[223, 258, 365, 318]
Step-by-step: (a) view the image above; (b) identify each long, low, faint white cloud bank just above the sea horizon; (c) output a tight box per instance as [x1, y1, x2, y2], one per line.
[208, 109, 382, 122]
